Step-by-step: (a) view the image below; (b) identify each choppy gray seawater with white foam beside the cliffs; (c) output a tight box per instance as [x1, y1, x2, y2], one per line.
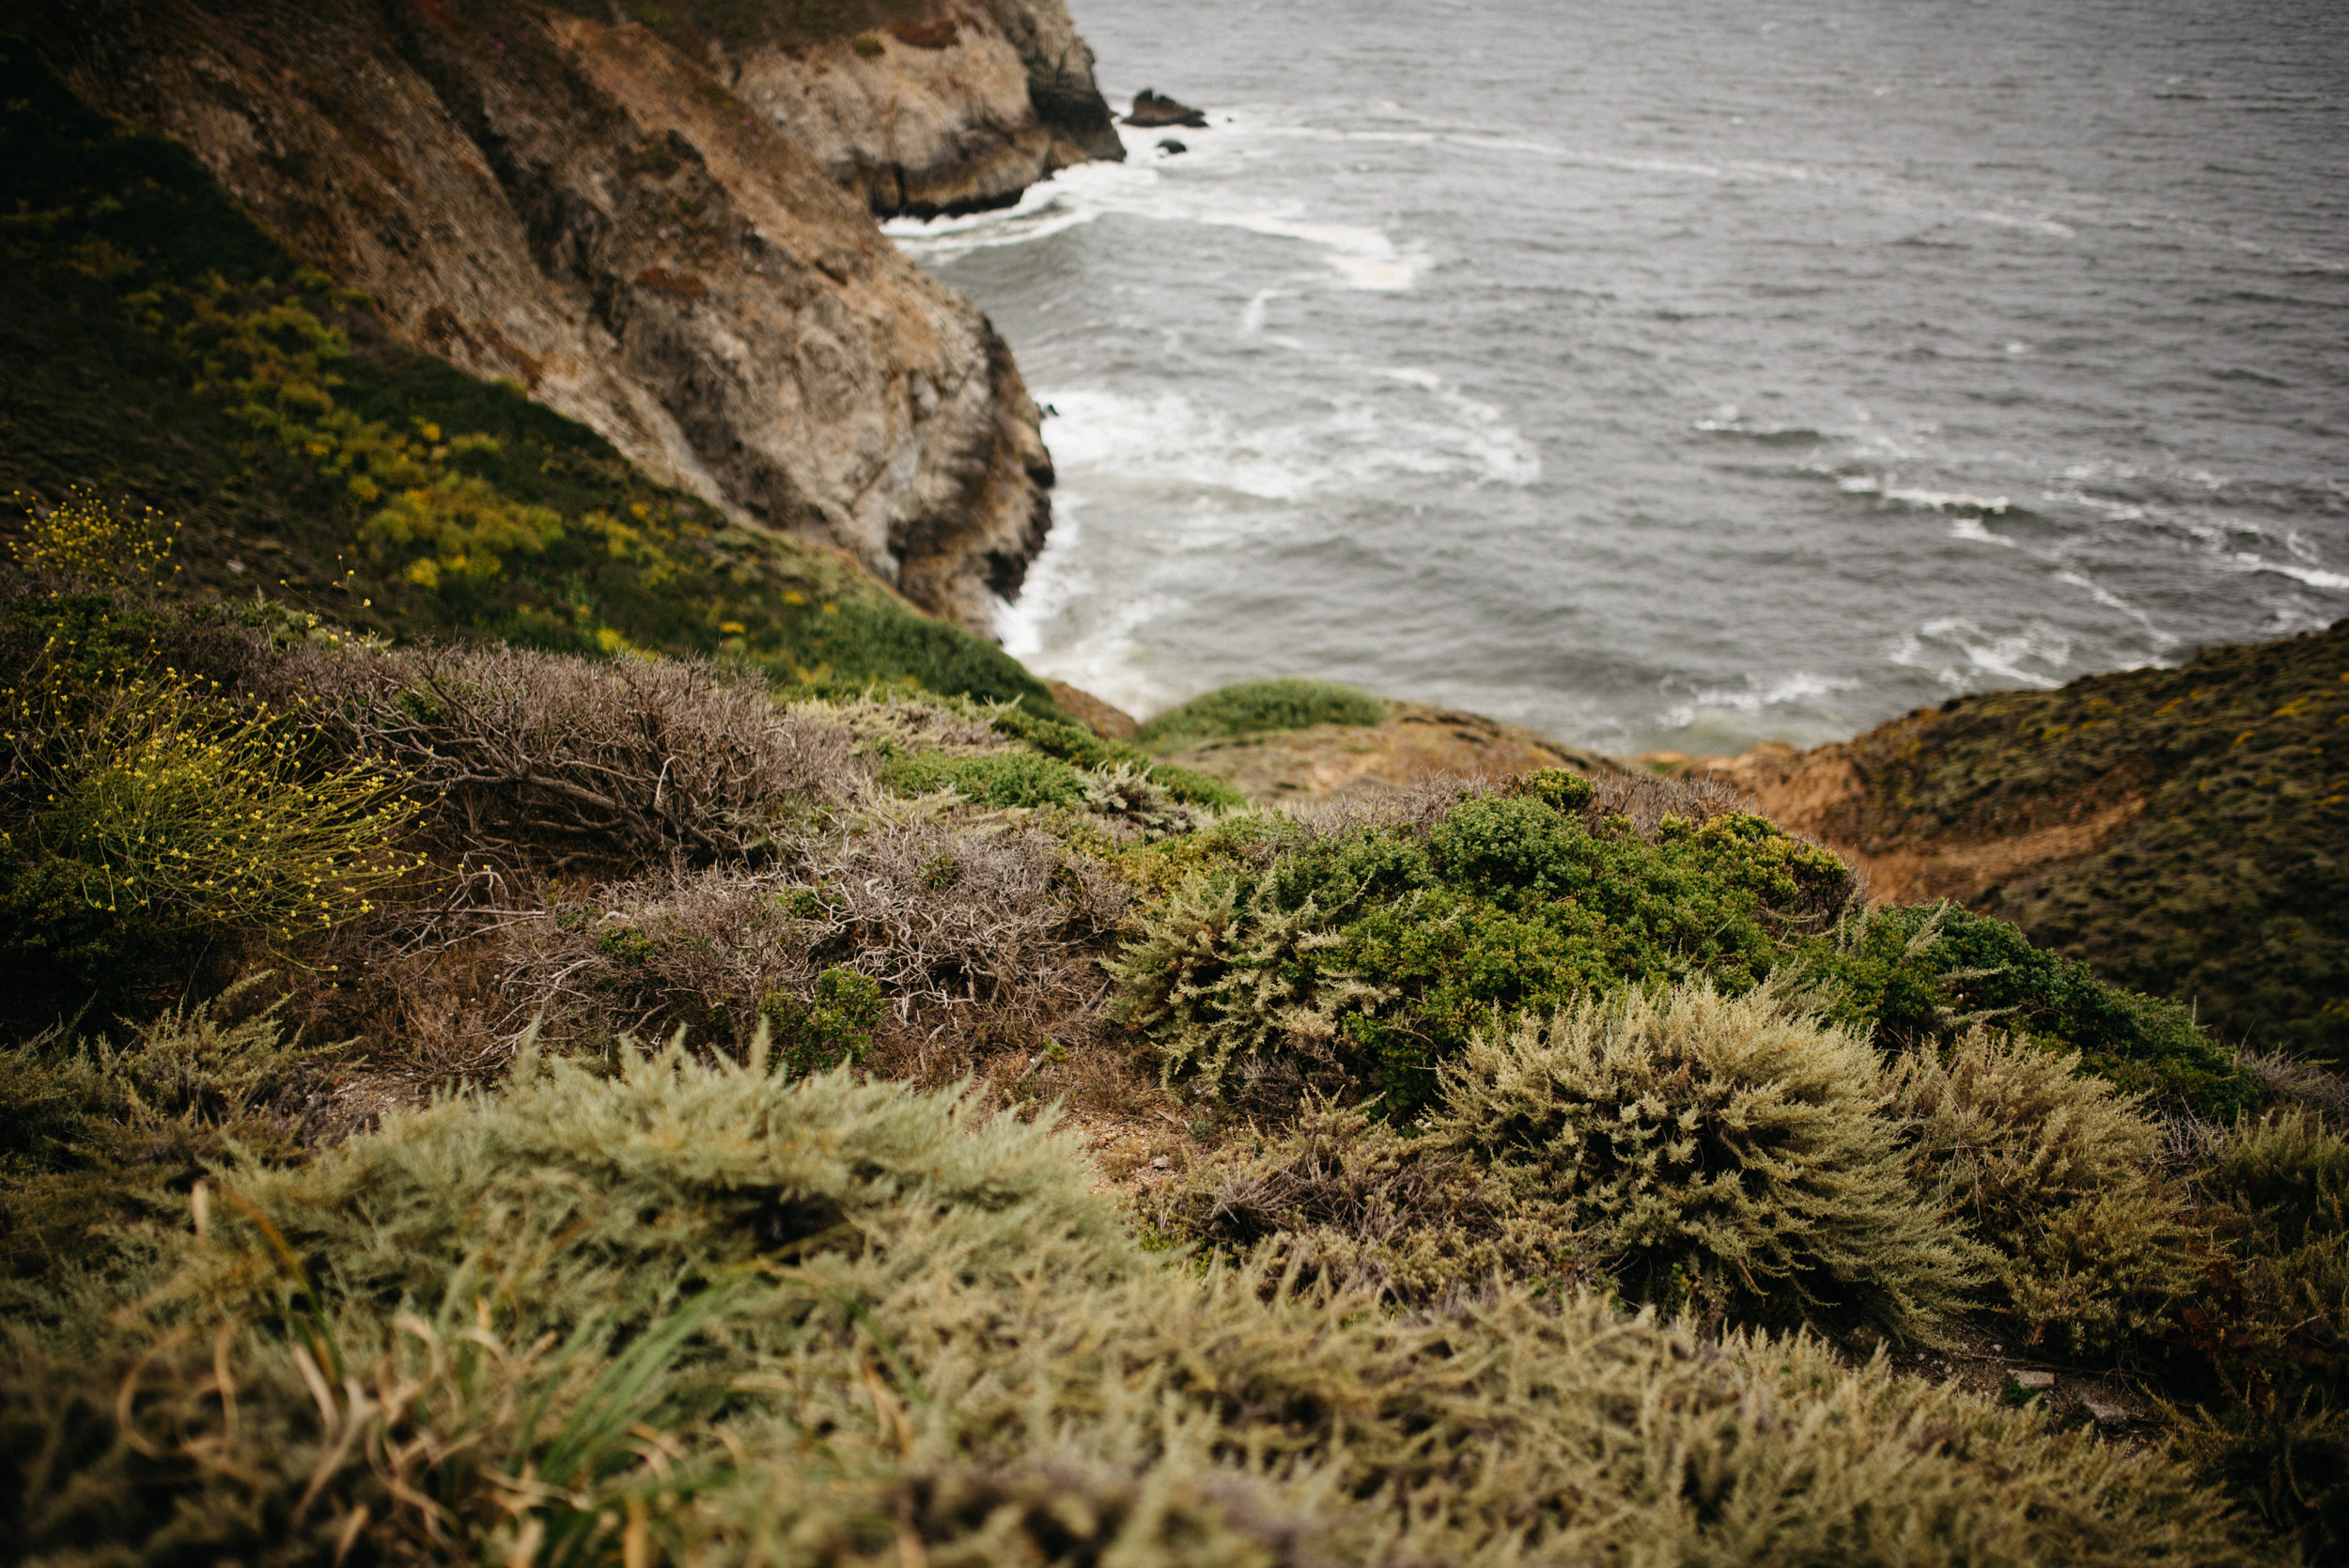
[891, 0, 2349, 752]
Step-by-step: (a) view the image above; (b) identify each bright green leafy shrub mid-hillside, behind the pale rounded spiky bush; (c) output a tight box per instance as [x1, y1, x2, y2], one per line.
[1113, 791, 1851, 1115]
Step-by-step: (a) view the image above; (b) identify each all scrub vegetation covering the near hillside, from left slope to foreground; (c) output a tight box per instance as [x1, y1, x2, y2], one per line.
[0, 33, 2349, 1568]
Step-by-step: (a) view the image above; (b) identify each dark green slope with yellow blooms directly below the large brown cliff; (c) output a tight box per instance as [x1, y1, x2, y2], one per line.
[0, 42, 1060, 716]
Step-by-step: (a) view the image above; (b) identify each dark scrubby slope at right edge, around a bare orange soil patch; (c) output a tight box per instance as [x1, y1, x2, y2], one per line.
[1840, 622, 2349, 1061]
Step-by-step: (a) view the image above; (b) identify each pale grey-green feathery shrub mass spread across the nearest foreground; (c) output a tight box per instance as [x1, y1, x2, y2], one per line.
[0, 1054, 2248, 1568]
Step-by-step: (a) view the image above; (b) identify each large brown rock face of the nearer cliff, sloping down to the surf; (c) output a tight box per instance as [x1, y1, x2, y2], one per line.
[50, 0, 1090, 634]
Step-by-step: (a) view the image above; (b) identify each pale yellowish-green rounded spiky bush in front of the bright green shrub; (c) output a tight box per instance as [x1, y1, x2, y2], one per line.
[1436, 984, 1981, 1338]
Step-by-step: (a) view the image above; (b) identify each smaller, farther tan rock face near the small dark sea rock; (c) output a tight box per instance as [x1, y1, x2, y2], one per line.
[712, 0, 1126, 218]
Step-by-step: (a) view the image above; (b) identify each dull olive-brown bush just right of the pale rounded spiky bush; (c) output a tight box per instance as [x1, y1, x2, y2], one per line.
[1893, 1028, 2206, 1355]
